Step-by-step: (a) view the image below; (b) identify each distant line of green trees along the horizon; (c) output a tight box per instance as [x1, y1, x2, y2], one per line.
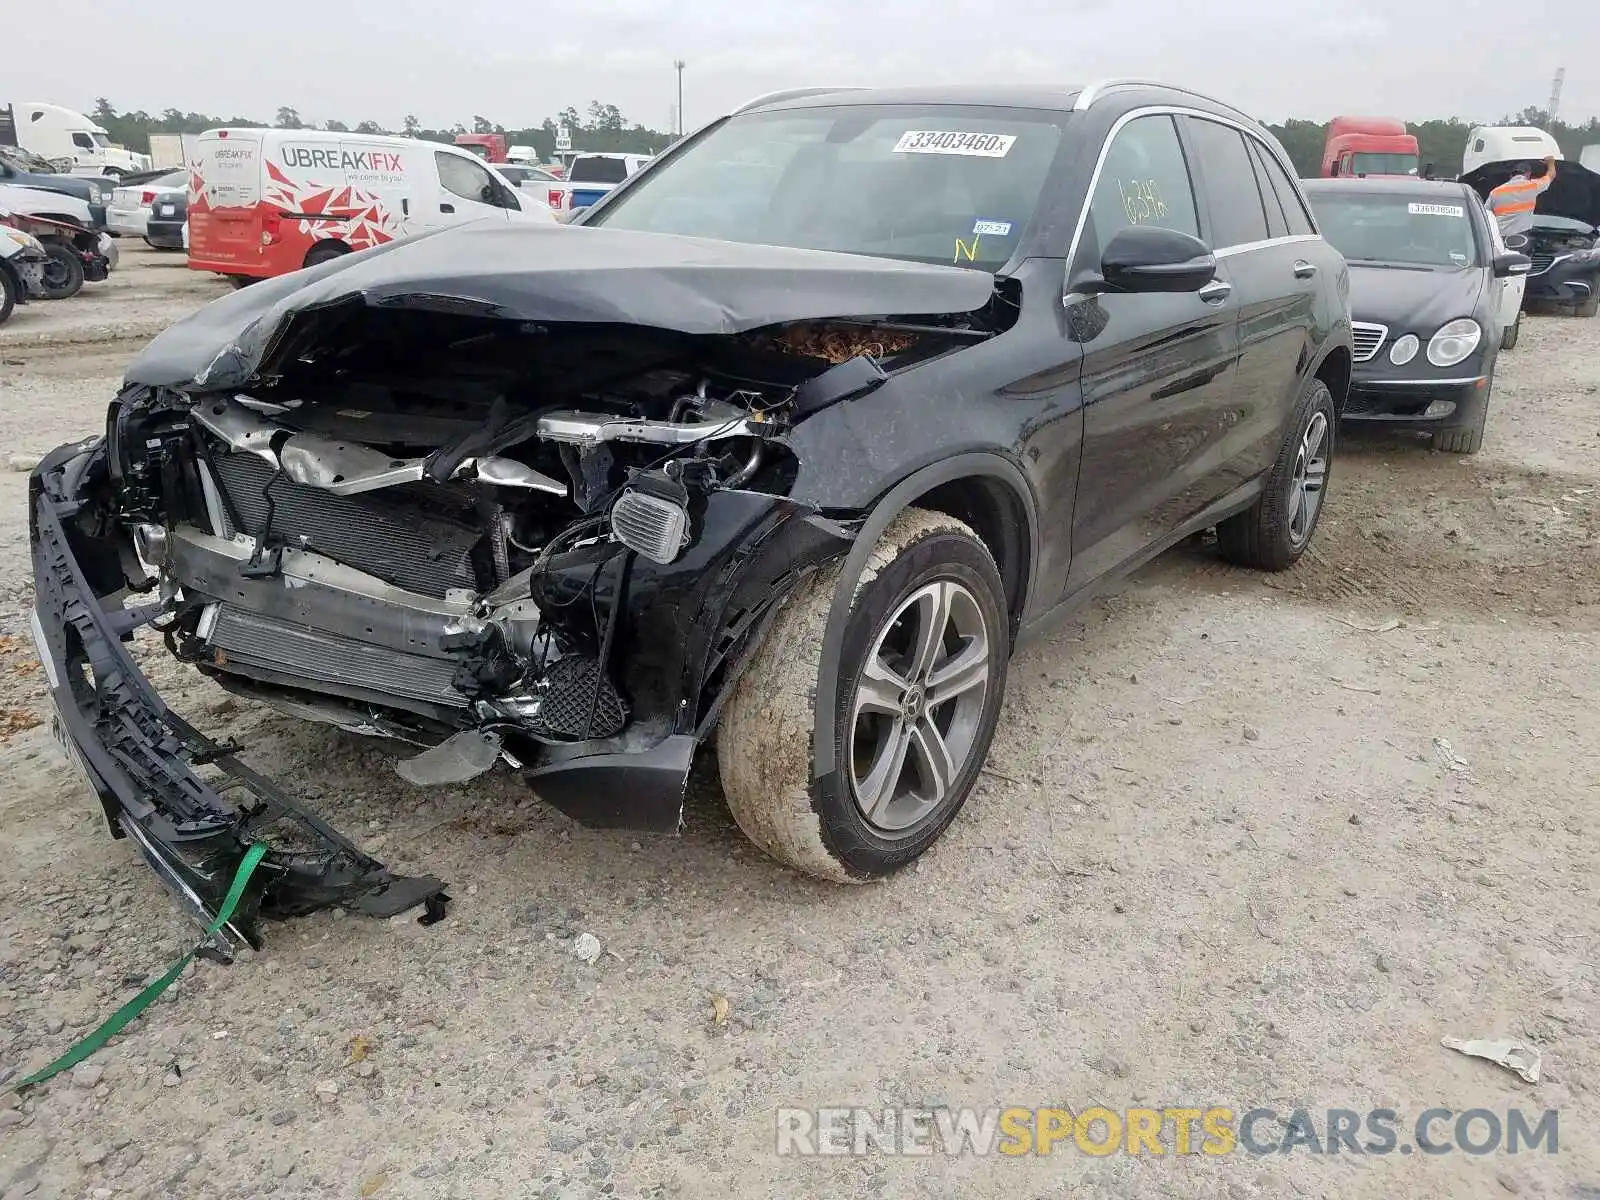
[93, 96, 1600, 178]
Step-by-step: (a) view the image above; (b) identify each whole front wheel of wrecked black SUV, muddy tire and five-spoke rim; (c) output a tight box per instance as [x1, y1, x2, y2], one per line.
[717, 509, 1011, 883]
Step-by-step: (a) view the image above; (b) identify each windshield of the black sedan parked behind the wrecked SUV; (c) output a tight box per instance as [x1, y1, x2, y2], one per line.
[1310, 189, 1482, 269]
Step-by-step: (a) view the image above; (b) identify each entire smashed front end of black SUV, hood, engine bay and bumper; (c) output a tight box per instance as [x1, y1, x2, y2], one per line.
[32, 229, 1014, 934]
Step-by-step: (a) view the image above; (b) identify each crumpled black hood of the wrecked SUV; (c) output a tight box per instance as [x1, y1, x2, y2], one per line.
[126, 219, 994, 387]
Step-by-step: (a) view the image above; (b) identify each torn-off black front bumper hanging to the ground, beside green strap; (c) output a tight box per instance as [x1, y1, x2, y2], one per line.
[30, 446, 448, 962]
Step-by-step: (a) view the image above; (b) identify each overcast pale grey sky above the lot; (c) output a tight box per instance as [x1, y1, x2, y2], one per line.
[15, 0, 1600, 128]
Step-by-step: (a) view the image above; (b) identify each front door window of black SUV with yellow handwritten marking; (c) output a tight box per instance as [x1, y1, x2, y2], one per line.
[1090, 114, 1200, 251]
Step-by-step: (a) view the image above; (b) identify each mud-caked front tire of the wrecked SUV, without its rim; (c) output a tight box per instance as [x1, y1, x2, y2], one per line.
[717, 509, 1010, 883]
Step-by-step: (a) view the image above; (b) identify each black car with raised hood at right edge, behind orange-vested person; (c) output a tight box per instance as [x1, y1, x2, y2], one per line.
[1461, 160, 1600, 317]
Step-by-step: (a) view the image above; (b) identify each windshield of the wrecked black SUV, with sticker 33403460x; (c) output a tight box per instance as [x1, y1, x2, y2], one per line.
[586, 104, 1062, 270]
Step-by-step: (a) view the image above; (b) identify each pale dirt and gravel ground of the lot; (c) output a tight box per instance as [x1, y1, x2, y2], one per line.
[0, 248, 1600, 1200]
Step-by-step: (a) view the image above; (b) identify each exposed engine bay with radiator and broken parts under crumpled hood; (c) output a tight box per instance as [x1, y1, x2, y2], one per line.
[109, 309, 971, 784]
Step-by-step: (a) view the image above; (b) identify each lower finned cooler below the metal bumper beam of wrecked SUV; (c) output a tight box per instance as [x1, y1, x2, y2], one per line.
[210, 605, 467, 709]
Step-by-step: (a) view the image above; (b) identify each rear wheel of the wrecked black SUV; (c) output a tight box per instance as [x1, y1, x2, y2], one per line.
[1216, 376, 1338, 571]
